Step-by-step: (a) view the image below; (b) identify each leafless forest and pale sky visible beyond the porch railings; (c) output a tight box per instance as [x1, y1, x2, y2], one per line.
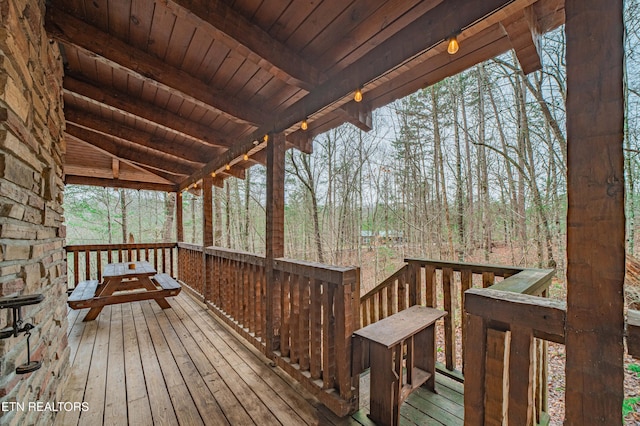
[64, 0, 640, 289]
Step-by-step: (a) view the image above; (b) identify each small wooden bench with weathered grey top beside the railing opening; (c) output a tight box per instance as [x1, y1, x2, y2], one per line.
[353, 306, 447, 425]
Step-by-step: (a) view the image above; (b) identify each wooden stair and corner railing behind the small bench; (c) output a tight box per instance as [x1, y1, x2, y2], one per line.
[360, 259, 555, 424]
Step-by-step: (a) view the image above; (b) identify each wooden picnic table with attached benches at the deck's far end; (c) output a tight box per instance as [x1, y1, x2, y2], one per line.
[67, 262, 182, 321]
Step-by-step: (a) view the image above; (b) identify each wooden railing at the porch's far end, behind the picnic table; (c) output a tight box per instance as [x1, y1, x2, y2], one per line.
[65, 243, 177, 289]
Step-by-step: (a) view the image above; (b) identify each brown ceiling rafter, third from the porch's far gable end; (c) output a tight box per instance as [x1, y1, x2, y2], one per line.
[64, 74, 231, 147]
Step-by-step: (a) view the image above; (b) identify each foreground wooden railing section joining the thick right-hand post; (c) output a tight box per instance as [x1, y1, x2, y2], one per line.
[464, 288, 566, 426]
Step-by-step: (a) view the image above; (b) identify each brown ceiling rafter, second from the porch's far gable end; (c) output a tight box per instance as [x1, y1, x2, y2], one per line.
[64, 107, 215, 164]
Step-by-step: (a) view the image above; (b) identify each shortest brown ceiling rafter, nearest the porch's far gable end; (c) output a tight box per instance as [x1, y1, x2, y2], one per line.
[66, 123, 200, 176]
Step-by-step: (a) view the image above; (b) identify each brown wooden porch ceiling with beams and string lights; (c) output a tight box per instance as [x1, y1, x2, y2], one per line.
[46, 0, 564, 191]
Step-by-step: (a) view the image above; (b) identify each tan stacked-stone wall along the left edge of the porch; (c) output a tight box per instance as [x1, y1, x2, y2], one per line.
[0, 0, 69, 425]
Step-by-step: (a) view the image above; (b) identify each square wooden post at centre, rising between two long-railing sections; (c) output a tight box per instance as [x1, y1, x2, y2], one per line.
[265, 133, 285, 356]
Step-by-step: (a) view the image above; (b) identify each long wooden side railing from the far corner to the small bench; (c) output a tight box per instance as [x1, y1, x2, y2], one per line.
[178, 243, 360, 416]
